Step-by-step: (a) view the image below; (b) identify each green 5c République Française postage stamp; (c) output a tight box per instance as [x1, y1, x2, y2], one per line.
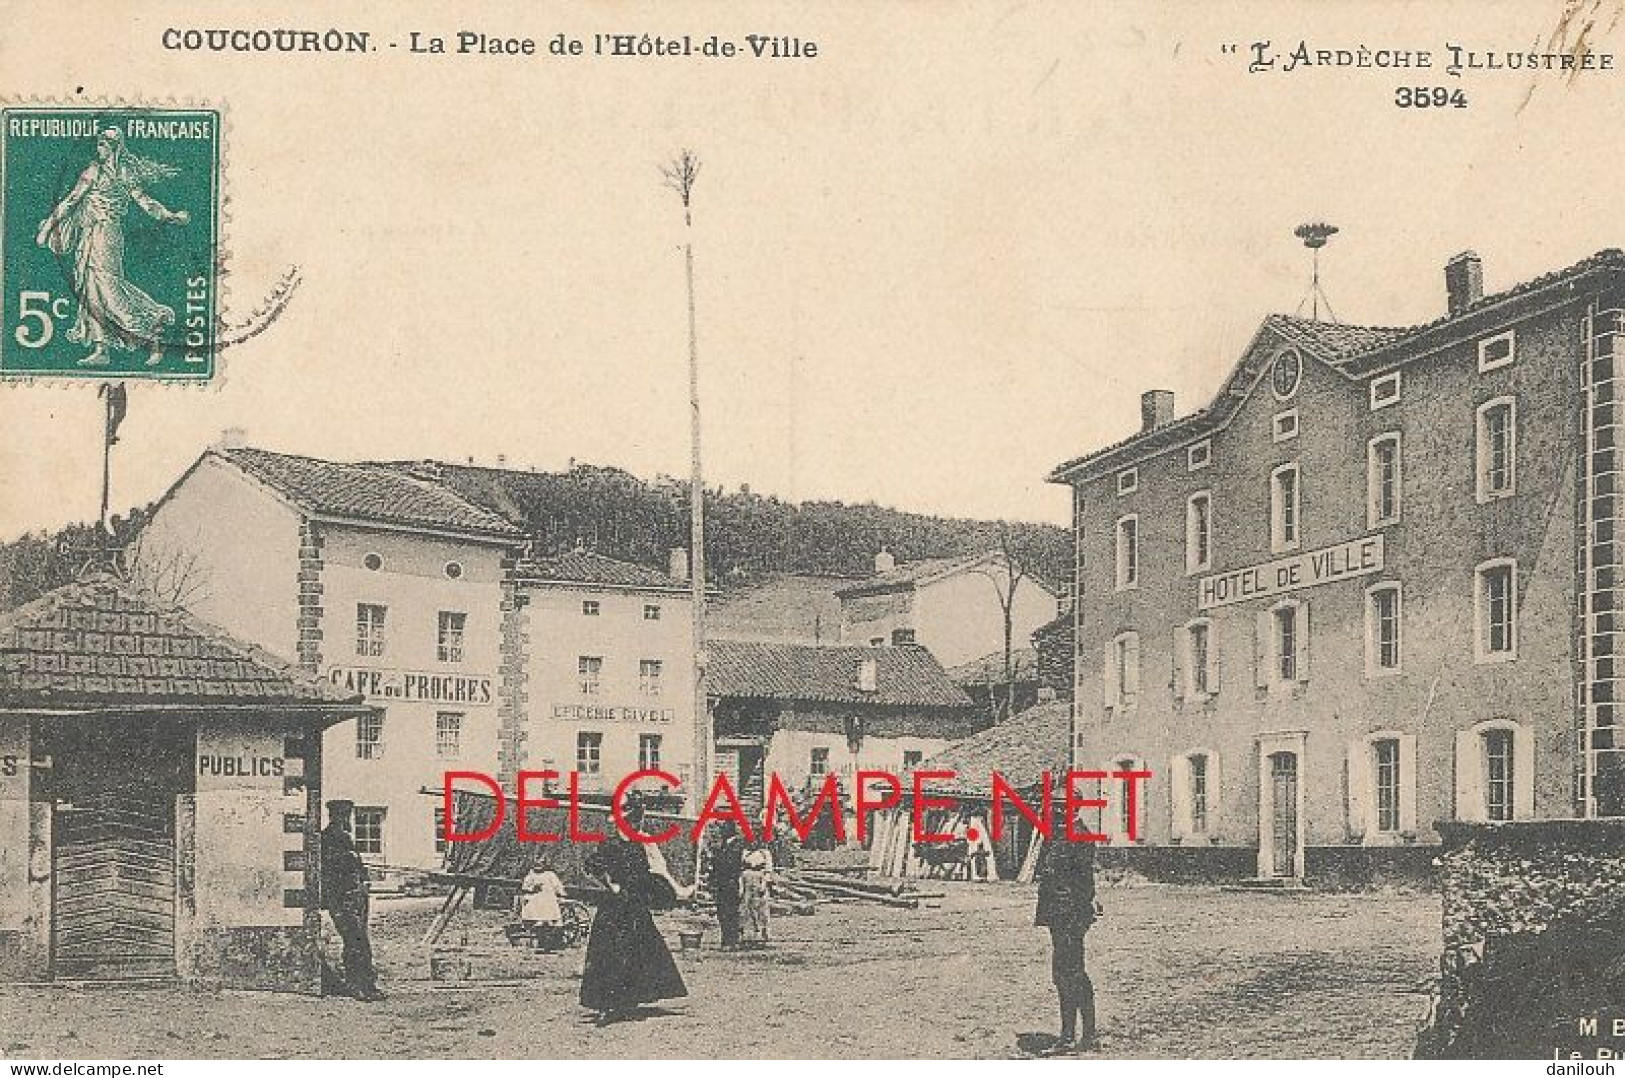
[0, 107, 221, 382]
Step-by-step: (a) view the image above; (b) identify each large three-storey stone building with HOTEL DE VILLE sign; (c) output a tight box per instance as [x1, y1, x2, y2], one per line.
[1050, 250, 1625, 881]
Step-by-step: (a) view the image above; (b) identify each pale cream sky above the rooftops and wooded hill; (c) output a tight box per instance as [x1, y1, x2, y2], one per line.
[0, 0, 1625, 538]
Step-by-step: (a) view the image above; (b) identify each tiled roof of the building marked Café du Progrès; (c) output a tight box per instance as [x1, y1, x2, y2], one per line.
[215, 449, 520, 538]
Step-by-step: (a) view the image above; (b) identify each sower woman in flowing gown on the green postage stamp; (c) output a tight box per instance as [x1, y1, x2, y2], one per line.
[34, 127, 192, 367]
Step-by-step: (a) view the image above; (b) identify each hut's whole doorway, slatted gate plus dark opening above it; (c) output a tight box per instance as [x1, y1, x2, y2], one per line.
[39, 715, 195, 980]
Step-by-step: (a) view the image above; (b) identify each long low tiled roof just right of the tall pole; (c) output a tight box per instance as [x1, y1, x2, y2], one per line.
[705, 641, 973, 711]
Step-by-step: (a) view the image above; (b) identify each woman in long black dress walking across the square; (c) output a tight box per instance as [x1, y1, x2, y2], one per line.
[582, 797, 689, 1024]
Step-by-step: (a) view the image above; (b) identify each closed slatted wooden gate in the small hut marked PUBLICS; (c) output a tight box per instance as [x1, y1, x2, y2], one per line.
[50, 790, 176, 980]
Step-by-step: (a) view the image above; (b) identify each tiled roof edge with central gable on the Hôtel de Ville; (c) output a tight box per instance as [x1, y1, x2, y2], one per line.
[1050, 247, 1625, 483]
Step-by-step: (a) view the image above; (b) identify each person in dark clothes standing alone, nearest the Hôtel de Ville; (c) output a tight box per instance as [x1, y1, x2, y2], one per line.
[1034, 813, 1100, 1052]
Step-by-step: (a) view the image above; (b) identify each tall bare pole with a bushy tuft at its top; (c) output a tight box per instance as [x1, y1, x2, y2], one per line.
[661, 150, 713, 808]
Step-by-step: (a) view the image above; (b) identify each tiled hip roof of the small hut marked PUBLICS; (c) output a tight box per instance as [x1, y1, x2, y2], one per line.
[0, 574, 367, 714]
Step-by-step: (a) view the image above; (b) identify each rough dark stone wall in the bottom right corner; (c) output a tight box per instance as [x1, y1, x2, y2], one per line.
[1417, 819, 1625, 1058]
